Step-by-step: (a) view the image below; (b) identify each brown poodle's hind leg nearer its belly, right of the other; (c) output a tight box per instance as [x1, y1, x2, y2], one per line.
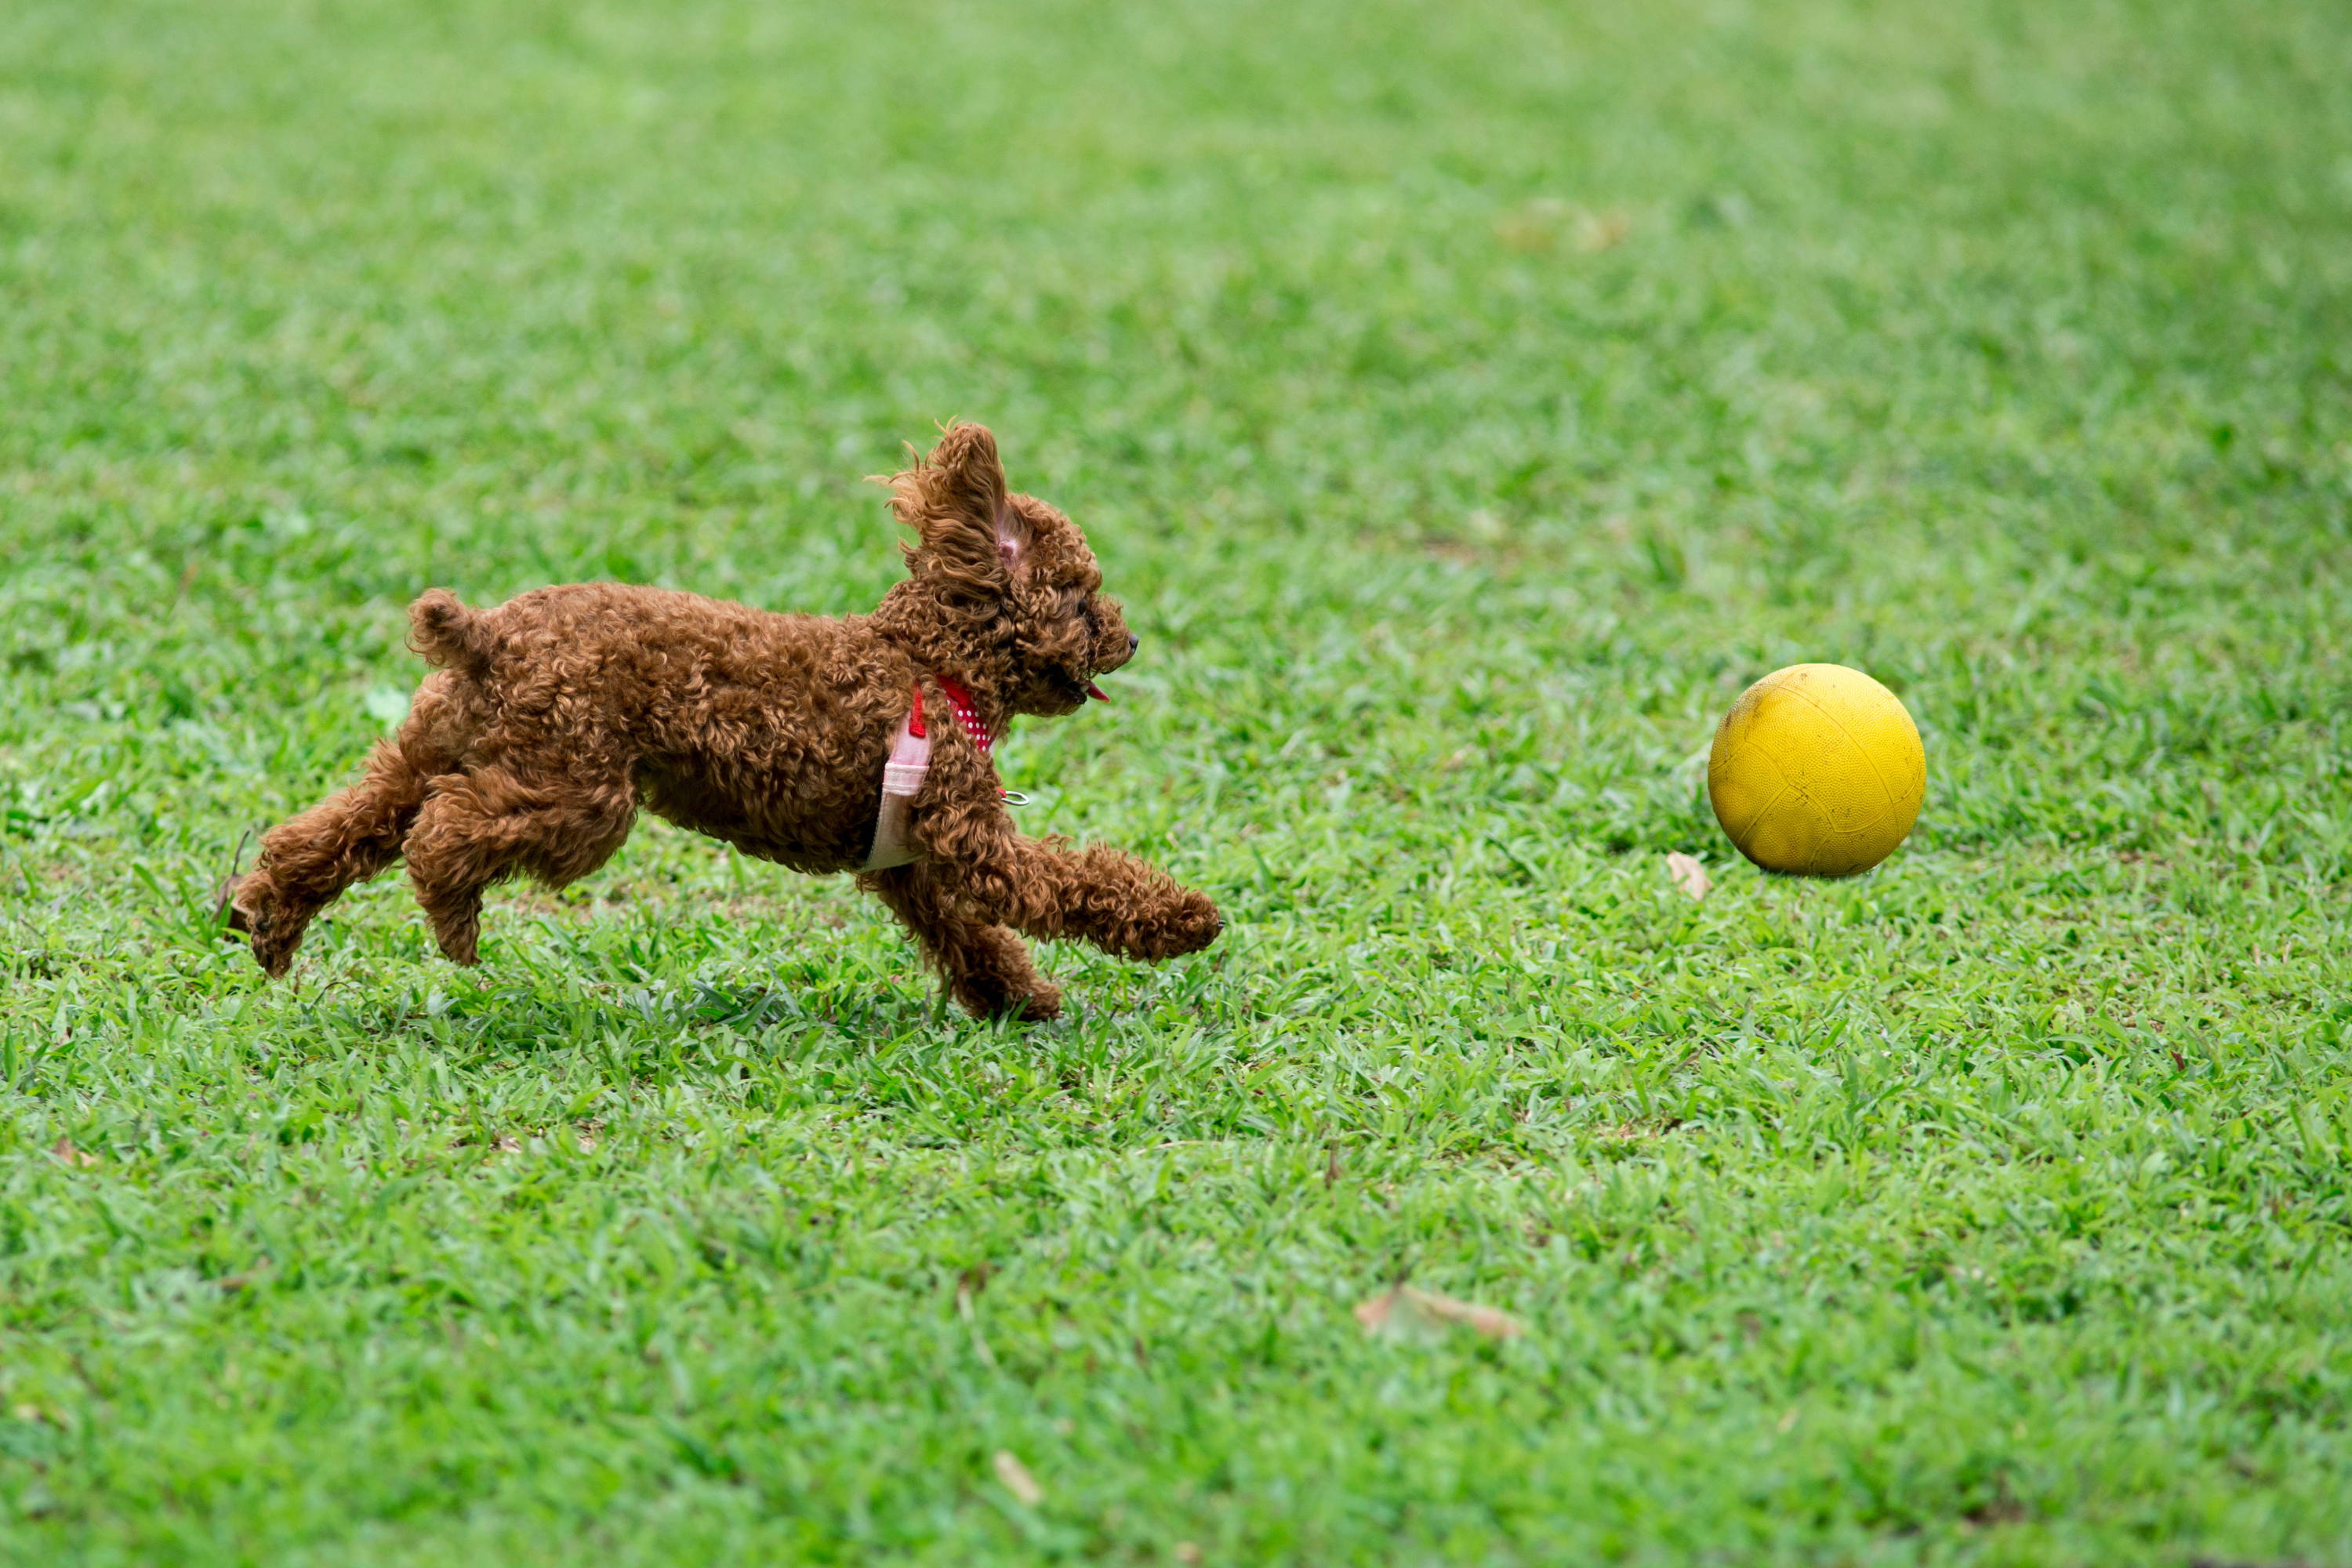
[405, 769, 637, 964]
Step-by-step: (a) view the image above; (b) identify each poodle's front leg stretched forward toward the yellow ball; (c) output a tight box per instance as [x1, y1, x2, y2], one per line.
[915, 799, 1225, 959]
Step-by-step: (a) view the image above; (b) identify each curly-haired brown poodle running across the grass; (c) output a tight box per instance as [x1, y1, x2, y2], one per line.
[226, 426, 1221, 1018]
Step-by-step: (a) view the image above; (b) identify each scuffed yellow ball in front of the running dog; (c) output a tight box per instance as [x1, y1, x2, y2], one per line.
[1708, 666, 1926, 877]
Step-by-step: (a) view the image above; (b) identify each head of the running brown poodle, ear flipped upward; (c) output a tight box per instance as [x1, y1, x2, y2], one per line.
[884, 426, 1136, 715]
